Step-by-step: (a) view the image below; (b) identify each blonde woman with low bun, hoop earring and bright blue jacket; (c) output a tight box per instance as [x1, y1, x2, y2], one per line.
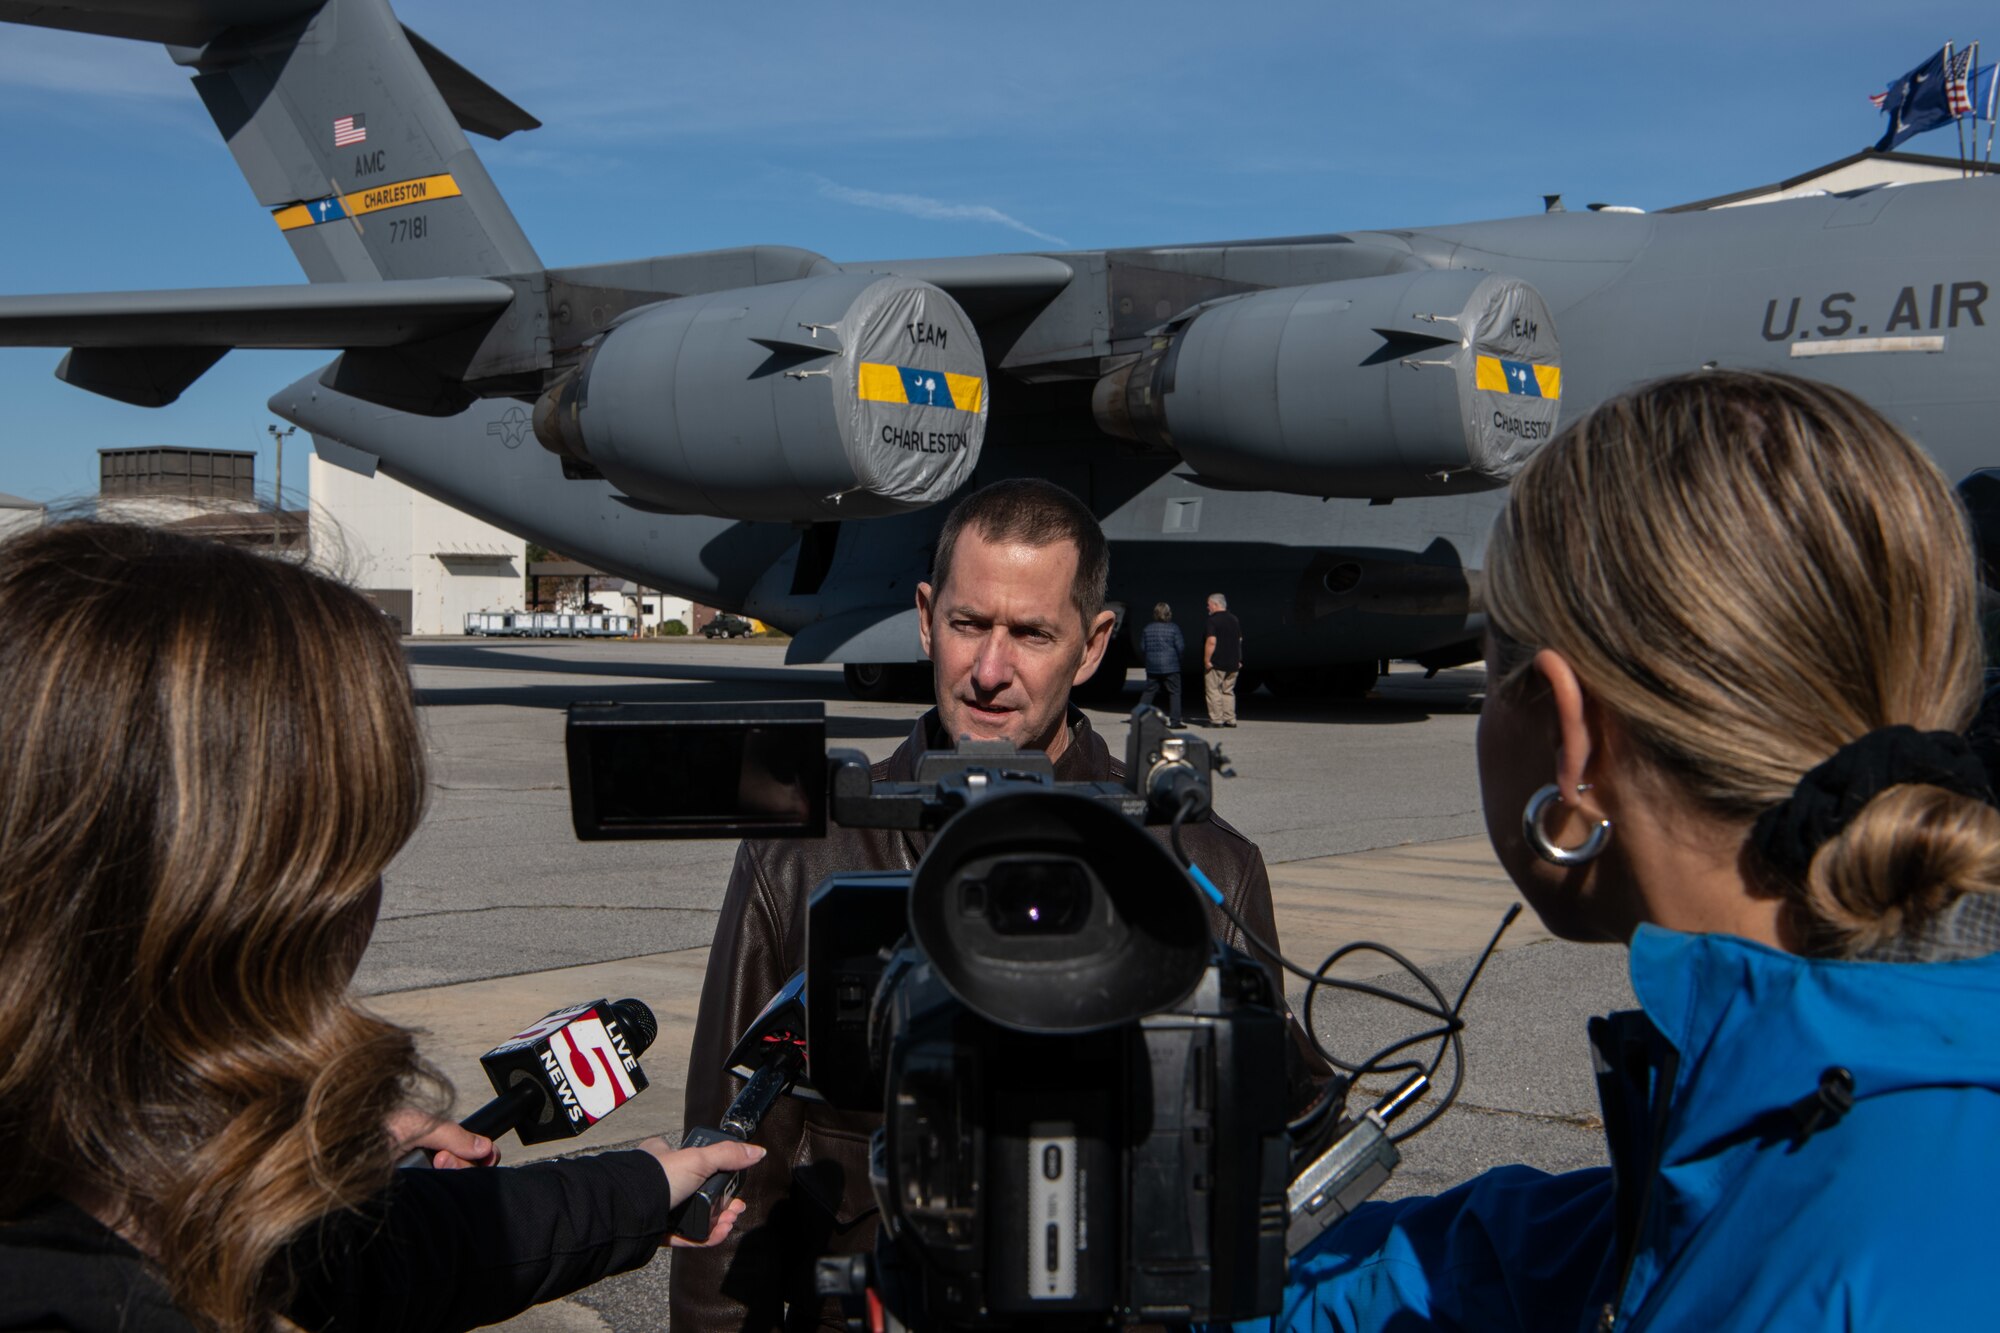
[1238, 372, 2000, 1333]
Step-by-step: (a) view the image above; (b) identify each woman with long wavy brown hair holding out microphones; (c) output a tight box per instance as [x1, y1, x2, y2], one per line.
[0, 522, 758, 1333]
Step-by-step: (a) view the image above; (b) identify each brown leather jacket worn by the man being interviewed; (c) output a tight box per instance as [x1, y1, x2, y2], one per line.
[670, 709, 1282, 1333]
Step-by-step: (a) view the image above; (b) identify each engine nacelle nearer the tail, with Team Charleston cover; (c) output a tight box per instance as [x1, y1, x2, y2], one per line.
[534, 274, 988, 522]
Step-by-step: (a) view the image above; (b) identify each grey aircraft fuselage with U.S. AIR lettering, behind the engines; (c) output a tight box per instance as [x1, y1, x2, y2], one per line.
[272, 180, 2000, 669]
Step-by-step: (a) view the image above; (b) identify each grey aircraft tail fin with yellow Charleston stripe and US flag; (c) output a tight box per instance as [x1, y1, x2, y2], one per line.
[173, 0, 542, 282]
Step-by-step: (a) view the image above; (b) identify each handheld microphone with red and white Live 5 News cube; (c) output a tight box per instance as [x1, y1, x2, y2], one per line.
[396, 999, 660, 1167]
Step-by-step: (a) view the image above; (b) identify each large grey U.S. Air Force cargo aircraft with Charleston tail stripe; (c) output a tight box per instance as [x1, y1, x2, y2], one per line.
[0, 0, 2000, 695]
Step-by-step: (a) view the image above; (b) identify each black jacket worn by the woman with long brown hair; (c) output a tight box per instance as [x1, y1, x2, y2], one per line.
[0, 1151, 670, 1333]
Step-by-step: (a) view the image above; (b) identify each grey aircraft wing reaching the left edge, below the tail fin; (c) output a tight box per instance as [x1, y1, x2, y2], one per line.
[0, 278, 514, 350]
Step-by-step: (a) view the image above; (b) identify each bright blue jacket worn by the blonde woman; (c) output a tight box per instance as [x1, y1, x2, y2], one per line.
[1238, 927, 2000, 1333]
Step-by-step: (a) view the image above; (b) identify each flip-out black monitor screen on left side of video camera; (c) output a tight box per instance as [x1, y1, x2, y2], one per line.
[566, 703, 826, 841]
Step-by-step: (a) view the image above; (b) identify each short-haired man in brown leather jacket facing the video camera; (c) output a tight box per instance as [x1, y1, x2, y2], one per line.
[670, 480, 1278, 1333]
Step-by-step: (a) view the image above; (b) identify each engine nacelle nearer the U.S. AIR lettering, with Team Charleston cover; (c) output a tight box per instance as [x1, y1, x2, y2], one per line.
[1092, 268, 1562, 498]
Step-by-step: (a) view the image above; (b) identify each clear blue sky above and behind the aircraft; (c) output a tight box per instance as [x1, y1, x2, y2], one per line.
[0, 0, 1976, 500]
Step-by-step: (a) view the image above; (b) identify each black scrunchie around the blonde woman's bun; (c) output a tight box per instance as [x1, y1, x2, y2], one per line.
[1750, 727, 1992, 883]
